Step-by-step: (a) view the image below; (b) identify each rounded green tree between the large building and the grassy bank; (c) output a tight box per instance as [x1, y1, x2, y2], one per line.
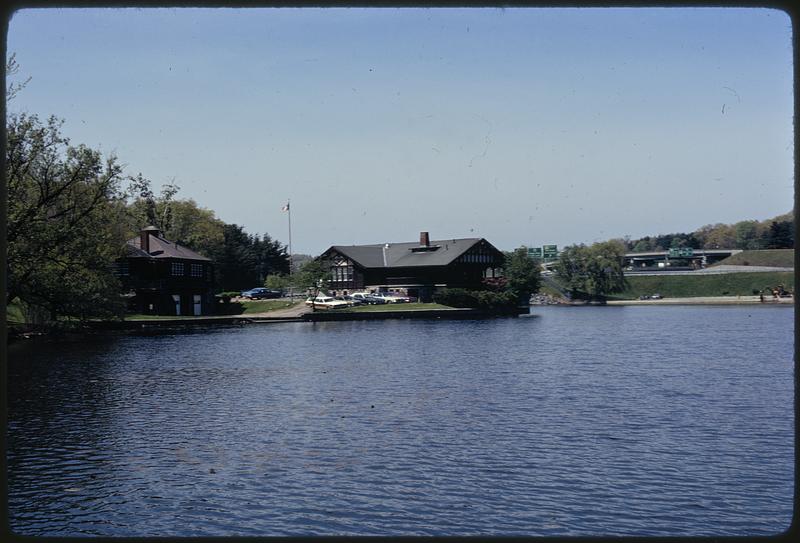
[556, 240, 625, 298]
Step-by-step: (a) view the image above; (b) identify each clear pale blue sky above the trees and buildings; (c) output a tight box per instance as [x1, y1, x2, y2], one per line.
[7, 8, 794, 254]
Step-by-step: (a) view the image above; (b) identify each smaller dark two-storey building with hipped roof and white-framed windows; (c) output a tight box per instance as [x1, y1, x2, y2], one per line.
[115, 226, 215, 316]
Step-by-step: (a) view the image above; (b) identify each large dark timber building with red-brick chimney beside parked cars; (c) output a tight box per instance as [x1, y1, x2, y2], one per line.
[319, 232, 505, 301]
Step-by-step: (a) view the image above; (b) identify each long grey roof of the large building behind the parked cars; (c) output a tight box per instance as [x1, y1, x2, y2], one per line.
[326, 238, 494, 268]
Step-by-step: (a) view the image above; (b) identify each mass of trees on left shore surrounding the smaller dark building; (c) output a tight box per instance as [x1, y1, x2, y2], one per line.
[4, 54, 289, 322]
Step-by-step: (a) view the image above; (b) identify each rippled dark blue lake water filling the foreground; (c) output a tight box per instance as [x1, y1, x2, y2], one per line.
[7, 306, 794, 536]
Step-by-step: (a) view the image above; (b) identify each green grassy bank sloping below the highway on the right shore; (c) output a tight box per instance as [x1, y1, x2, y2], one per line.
[609, 272, 794, 300]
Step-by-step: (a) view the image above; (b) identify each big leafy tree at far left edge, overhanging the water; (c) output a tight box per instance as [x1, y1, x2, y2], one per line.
[5, 113, 125, 319]
